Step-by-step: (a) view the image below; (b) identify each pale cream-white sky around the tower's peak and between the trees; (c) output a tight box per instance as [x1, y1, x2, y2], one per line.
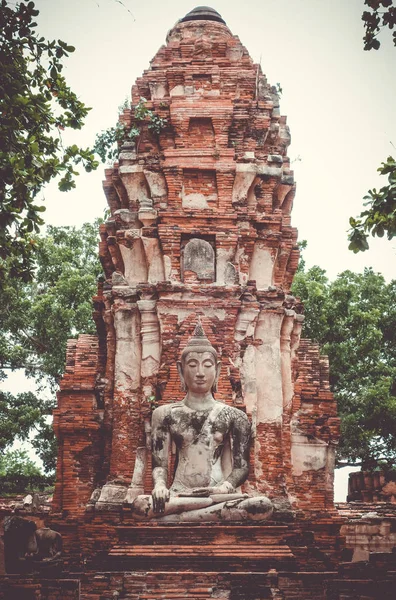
[9, 0, 396, 499]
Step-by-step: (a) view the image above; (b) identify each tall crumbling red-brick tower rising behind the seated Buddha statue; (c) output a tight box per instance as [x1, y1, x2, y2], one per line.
[51, 4, 338, 511]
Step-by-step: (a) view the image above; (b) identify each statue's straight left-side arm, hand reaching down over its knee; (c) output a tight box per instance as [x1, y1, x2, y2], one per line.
[151, 406, 170, 513]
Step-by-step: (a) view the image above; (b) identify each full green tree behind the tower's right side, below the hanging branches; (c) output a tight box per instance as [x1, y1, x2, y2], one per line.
[293, 266, 396, 469]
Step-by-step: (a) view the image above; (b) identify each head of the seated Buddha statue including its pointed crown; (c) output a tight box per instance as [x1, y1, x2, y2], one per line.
[177, 321, 221, 395]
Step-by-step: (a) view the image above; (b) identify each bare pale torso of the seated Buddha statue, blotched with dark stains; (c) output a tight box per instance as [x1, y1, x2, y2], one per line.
[153, 401, 250, 494]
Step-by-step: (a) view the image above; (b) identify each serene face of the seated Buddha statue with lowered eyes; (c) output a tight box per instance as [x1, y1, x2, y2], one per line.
[181, 352, 220, 395]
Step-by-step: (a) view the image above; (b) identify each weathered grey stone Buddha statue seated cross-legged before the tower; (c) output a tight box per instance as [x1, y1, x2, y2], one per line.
[128, 322, 273, 522]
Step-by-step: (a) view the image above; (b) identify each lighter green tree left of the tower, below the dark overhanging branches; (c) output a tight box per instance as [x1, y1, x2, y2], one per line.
[0, 222, 102, 470]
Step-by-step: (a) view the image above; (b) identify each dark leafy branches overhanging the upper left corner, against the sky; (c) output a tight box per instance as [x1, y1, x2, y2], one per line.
[0, 0, 98, 286]
